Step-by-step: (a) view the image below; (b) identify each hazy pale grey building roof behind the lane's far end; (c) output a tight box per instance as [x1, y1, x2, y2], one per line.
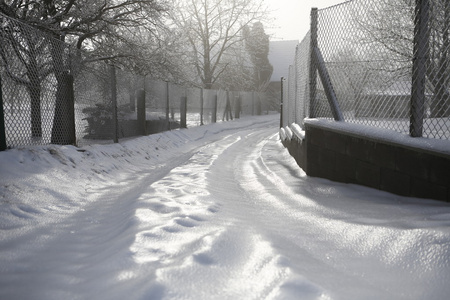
[269, 40, 298, 82]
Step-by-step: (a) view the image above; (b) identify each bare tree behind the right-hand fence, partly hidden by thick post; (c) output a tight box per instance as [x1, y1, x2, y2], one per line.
[353, 0, 450, 117]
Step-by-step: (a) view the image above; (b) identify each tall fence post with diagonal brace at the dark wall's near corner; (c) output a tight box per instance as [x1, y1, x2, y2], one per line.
[309, 7, 318, 118]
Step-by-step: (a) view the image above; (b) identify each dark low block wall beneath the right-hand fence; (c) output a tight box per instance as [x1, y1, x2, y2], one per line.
[284, 124, 450, 201]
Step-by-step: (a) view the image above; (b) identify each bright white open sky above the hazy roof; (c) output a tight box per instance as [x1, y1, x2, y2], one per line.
[266, 0, 346, 40]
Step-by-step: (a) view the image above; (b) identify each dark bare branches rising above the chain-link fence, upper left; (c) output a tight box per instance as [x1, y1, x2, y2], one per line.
[0, 0, 170, 65]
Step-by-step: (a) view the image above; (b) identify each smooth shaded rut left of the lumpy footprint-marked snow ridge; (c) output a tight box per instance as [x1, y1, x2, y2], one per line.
[0, 153, 201, 299]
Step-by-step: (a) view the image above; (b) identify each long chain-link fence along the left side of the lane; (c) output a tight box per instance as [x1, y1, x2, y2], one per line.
[0, 14, 270, 148]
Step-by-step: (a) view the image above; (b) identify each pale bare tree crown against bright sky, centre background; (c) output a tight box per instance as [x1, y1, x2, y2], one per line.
[174, 0, 266, 89]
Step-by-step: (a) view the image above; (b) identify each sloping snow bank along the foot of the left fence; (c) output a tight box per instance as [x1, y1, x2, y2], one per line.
[0, 116, 273, 229]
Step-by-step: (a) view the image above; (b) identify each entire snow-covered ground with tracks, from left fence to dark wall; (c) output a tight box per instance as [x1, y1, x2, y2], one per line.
[0, 115, 450, 299]
